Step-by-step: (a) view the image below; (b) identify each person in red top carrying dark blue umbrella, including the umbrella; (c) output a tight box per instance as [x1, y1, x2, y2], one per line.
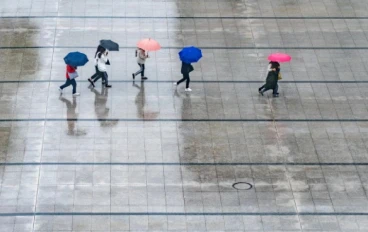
[59, 52, 88, 96]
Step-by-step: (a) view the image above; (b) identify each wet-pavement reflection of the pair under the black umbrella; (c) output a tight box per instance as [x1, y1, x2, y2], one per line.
[91, 87, 117, 127]
